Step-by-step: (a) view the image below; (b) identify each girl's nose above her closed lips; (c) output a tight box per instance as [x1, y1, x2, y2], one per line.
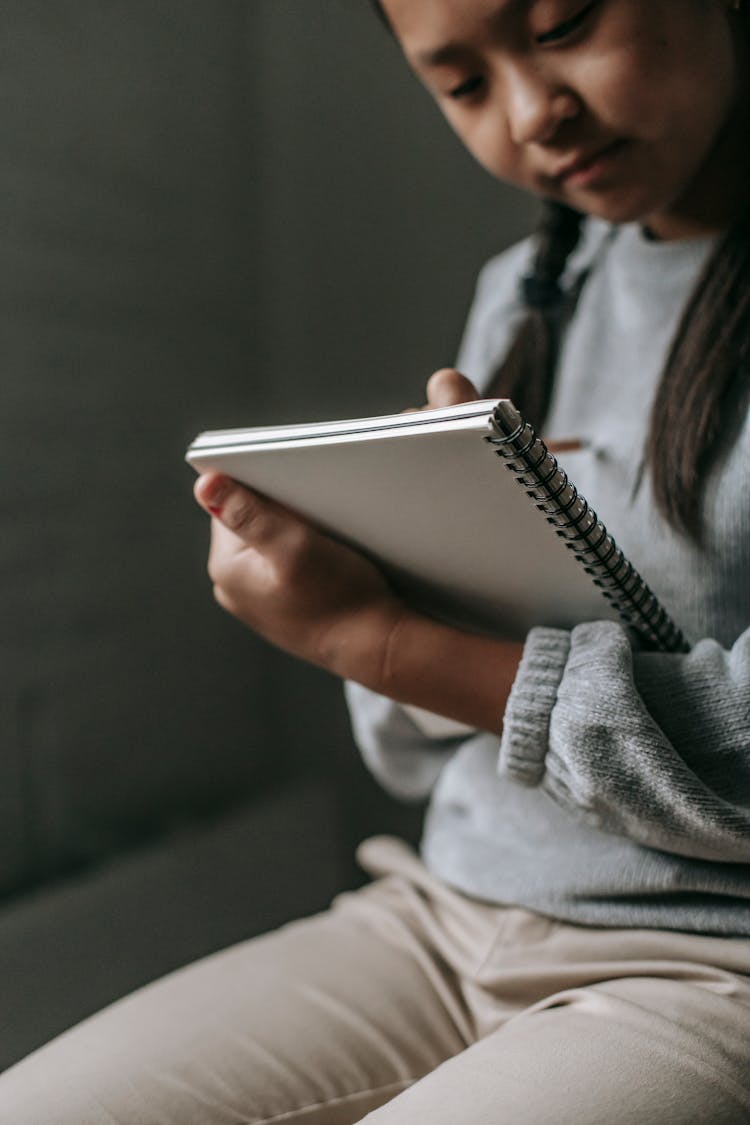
[504, 66, 580, 145]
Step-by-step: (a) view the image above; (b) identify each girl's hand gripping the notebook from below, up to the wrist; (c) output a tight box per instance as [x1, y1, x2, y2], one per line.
[195, 473, 406, 680]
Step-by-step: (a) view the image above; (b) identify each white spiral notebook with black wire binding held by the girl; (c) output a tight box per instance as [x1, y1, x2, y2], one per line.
[187, 399, 687, 650]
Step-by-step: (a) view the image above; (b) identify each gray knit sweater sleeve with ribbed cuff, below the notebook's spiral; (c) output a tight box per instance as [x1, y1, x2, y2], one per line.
[499, 621, 750, 863]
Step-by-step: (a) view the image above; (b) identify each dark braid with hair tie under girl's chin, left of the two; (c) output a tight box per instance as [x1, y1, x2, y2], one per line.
[487, 200, 584, 429]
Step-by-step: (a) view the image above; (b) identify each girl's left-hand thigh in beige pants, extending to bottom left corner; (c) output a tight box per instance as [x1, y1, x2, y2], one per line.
[0, 881, 466, 1125]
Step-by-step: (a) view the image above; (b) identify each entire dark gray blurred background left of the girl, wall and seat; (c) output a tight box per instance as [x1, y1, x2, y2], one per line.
[0, 0, 531, 1069]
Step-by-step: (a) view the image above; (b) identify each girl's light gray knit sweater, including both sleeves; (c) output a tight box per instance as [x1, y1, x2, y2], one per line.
[347, 222, 750, 935]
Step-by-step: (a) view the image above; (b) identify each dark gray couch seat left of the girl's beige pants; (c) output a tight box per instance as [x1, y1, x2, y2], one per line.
[0, 782, 353, 1069]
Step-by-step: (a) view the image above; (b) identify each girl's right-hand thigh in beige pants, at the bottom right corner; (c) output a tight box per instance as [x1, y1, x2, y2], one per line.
[367, 979, 750, 1125]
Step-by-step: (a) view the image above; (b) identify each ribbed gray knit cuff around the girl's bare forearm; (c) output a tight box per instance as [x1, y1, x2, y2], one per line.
[498, 629, 570, 788]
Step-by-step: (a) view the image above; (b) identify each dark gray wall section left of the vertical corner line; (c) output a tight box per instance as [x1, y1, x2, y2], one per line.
[0, 0, 269, 889]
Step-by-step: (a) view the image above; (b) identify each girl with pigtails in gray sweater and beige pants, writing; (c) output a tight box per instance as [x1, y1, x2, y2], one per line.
[0, 0, 750, 1125]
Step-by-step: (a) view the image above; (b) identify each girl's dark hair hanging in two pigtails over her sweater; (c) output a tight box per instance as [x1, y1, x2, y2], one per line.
[371, 0, 750, 542]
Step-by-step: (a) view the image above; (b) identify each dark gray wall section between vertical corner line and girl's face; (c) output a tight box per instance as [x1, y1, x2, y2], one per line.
[250, 0, 531, 419]
